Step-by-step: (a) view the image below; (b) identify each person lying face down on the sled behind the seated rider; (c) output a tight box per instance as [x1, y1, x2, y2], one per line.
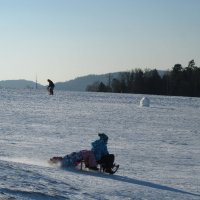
[50, 150, 98, 170]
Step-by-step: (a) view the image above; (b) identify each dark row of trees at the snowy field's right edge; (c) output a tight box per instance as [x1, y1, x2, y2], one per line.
[86, 60, 200, 97]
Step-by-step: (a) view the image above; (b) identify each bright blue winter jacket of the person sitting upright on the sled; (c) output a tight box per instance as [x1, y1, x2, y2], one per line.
[92, 139, 109, 161]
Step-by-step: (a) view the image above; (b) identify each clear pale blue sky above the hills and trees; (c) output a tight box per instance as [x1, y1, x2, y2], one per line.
[0, 0, 200, 84]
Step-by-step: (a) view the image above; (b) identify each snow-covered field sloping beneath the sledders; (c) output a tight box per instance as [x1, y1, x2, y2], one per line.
[0, 89, 200, 200]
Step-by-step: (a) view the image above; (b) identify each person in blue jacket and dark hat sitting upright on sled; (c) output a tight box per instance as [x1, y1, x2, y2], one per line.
[92, 133, 119, 174]
